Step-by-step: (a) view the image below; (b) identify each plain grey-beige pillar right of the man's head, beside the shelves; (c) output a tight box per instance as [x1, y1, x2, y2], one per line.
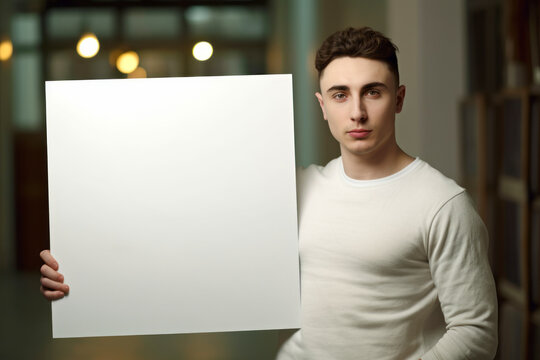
[387, 0, 466, 179]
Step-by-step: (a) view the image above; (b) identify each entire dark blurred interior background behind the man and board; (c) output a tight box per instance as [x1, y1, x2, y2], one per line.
[0, 0, 540, 359]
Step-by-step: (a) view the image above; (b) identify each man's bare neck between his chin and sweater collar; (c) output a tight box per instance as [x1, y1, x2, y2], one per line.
[341, 144, 414, 180]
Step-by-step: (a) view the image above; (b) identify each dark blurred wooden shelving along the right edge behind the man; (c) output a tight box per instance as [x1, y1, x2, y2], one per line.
[459, 0, 540, 360]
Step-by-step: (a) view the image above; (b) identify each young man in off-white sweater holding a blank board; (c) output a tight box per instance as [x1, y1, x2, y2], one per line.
[42, 28, 497, 360]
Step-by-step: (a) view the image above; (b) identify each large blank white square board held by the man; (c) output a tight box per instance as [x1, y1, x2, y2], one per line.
[46, 75, 300, 337]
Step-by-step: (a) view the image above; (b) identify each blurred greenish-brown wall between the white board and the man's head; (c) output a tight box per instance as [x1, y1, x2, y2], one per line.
[269, 0, 387, 167]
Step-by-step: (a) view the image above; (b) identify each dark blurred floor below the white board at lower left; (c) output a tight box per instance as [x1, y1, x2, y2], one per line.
[0, 273, 277, 360]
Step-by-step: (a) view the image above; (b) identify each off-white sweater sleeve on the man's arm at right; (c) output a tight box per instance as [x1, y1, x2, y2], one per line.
[422, 192, 497, 360]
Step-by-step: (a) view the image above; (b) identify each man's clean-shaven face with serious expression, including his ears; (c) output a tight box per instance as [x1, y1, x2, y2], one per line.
[315, 57, 405, 156]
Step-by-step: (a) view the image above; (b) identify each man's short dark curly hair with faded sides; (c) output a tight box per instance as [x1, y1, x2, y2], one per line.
[315, 26, 399, 86]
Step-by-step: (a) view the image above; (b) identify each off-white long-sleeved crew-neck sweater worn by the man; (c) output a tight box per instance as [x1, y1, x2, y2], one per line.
[278, 158, 497, 360]
